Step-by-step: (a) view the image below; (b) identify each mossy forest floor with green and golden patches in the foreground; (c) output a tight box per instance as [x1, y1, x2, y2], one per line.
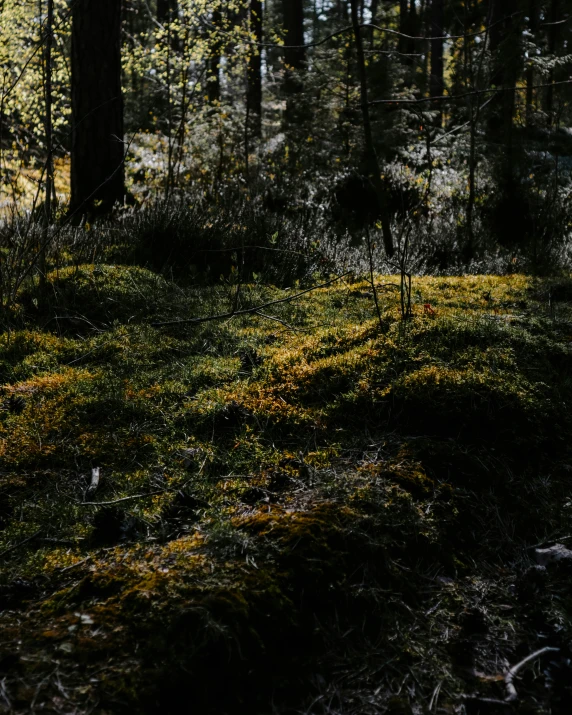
[0, 265, 572, 715]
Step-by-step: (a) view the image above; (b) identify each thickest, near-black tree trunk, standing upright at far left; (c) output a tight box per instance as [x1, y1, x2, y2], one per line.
[70, 0, 125, 215]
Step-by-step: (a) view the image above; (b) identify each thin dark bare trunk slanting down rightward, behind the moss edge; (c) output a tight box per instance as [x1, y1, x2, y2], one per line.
[351, 0, 394, 257]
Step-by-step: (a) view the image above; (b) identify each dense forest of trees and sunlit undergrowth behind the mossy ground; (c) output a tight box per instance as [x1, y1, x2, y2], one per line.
[0, 0, 572, 293]
